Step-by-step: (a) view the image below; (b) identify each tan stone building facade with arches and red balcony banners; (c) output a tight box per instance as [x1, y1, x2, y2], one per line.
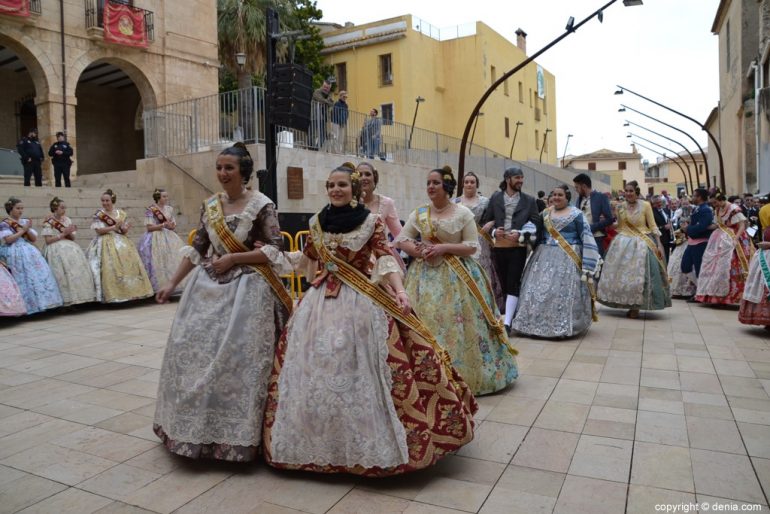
[0, 0, 218, 179]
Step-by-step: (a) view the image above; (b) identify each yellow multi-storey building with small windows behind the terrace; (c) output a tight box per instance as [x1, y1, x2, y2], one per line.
[323, 15, 558, 165]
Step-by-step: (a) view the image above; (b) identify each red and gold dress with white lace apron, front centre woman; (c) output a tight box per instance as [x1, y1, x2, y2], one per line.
[264, 213, 477, 476]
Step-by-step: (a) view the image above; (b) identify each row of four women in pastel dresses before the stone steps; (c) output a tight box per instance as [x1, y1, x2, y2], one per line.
[0, 189, 183, 316]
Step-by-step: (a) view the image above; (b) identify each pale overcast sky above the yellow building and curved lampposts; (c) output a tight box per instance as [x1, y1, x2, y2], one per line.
[318, 0, 719, 162]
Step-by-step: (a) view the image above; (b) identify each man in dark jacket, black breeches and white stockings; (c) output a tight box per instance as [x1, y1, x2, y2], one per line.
[481, 166, 543, 332]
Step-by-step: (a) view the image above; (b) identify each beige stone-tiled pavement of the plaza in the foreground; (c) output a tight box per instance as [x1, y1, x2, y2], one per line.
[0, 300, 770, 514]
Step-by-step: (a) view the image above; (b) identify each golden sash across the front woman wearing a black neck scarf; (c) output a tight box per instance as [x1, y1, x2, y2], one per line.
[310, 216, 459, 384]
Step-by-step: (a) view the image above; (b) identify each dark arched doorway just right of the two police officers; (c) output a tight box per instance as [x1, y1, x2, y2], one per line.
[75, 58, 155, 175]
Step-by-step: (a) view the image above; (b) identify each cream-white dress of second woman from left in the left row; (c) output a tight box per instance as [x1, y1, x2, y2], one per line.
[41, 216, 96, 305]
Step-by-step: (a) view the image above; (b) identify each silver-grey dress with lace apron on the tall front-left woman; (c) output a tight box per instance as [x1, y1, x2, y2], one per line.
[153, 192, 292, 461]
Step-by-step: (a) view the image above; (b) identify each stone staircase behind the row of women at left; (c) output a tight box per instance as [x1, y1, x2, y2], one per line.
[0, 171, 198, 250]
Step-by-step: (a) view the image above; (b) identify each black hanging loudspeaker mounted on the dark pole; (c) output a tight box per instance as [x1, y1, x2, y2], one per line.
[268, 64, 313, 131]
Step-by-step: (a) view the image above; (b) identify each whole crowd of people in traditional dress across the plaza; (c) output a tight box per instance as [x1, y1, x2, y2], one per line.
[6, 143, 770, 476]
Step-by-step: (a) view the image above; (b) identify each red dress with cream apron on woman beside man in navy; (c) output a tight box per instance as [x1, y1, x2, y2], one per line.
[695, 203, 753, 305]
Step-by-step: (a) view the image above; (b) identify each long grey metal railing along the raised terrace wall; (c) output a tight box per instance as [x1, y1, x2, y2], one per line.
[143, 87, 610, 191]
